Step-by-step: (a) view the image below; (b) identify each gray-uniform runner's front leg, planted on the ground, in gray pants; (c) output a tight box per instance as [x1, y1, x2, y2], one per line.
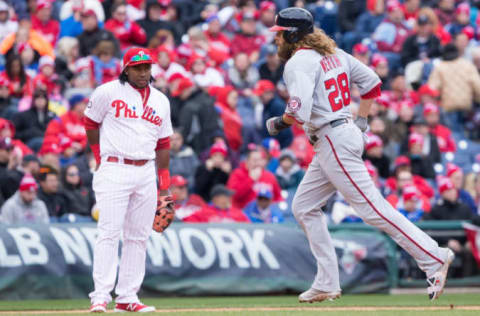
[292, 154, 340, 298]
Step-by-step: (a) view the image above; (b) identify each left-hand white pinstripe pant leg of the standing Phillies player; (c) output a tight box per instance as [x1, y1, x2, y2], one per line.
[89, 163, 131, 304]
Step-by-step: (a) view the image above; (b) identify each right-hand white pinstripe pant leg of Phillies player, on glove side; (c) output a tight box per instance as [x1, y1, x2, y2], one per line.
[115, 162, 157, 304]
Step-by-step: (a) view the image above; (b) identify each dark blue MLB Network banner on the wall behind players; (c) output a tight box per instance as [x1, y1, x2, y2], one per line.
[0, 224, 388, 299]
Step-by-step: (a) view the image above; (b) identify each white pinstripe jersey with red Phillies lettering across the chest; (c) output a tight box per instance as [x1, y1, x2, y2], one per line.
[85, 80, 173, 160]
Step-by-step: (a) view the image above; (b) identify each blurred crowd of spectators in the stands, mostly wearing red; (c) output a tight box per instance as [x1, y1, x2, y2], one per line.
[0, 0, 480, 236]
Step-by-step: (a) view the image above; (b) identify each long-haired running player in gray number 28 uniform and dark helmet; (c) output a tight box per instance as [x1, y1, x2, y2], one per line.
[266, 8, 454, 302]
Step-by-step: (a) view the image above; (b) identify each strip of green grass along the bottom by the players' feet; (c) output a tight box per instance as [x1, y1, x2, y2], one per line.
[0, 294, 480, 316]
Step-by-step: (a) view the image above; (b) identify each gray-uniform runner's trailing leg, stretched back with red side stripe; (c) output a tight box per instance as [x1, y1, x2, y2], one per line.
[320, 124, 448, 292]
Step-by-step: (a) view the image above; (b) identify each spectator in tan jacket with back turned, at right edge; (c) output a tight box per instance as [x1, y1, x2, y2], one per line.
[428, 44, 480, 131]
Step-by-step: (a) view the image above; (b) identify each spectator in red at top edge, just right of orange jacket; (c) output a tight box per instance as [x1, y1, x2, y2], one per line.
[32, 0, 60, 47]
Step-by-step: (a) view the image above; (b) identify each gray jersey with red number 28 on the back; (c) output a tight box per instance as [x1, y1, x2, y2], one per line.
[283, 48, 380, 130]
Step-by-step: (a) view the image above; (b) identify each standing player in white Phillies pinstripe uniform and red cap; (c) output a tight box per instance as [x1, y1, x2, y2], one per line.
[85, 48, 173, 312]
